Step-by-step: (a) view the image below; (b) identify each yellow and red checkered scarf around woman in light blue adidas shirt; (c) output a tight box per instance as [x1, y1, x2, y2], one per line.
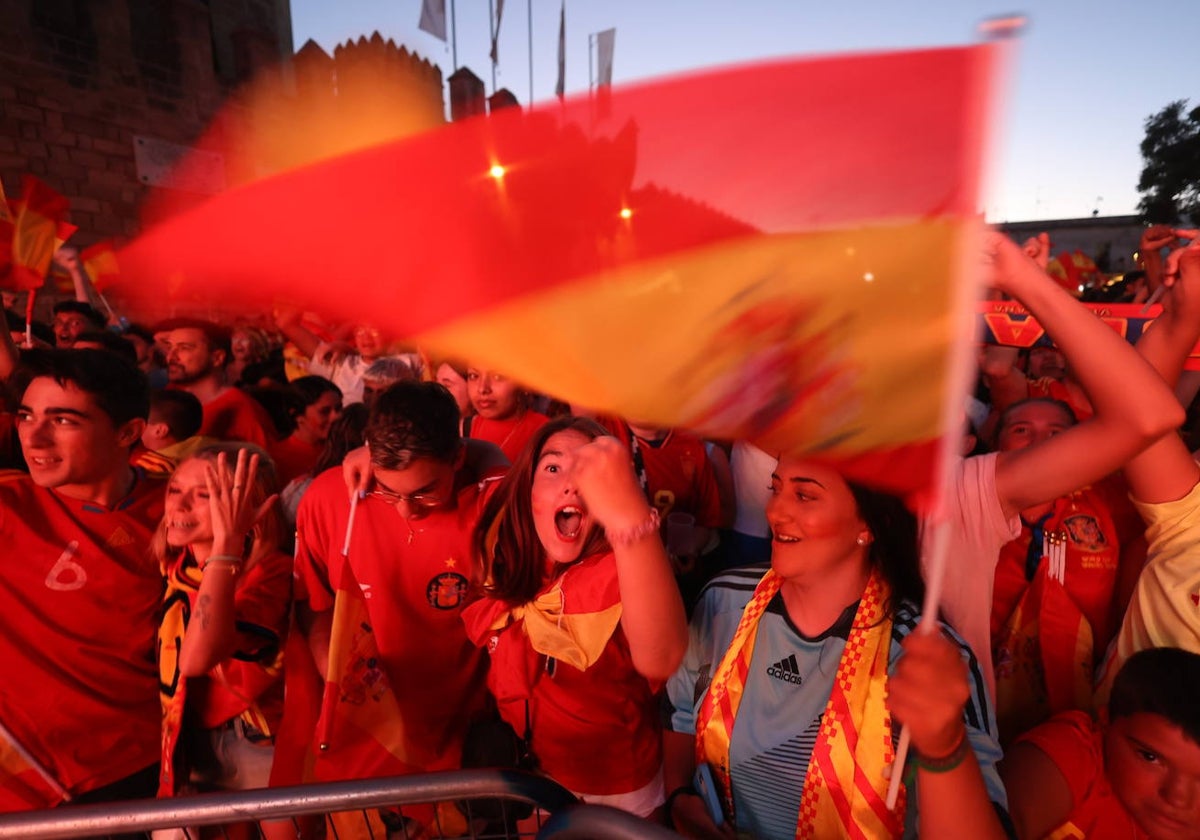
[696, 571, 905, 838]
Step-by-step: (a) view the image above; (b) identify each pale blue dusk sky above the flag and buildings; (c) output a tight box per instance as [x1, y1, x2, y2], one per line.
[292, 0, 1200, 221]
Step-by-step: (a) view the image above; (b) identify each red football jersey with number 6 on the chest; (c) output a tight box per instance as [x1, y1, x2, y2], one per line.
[0, 473, 163, 810]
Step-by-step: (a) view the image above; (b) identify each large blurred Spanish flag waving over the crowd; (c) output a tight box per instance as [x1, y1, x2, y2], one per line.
[120, 44, 997, 488]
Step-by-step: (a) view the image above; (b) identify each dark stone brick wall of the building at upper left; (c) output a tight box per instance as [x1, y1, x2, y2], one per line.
[0, 0, 292, 246]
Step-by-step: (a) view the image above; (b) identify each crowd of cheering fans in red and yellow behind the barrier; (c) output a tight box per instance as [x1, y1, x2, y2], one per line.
[0, 228, 1200, 840]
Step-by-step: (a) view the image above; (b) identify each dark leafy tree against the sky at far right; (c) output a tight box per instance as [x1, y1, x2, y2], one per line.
[1138, 100, 1200, 224]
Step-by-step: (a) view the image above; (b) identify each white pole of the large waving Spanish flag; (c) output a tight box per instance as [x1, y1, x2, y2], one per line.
[887, 14, 1026, 810]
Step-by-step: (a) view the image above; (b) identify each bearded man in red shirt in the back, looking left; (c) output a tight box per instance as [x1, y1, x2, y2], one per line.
[163, 318, 275, 449]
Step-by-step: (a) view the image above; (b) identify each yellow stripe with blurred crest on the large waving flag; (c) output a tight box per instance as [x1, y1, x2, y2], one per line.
[415, 220, 974, 456]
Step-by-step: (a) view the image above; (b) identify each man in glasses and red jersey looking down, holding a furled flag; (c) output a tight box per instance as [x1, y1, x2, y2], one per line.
[281, 382, 491, 801]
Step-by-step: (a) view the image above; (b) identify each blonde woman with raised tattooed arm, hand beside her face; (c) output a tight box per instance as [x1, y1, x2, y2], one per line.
[151, 443, 292, 796]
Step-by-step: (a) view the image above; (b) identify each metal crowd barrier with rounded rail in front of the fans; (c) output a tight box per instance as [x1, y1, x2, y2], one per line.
[0, 769, 678, 840]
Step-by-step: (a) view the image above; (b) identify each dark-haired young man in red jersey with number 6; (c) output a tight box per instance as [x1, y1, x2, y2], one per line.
[0, 350, 163, 811]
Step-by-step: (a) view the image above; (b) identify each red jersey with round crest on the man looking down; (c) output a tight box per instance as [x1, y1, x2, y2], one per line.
[296, 469, 494, 779]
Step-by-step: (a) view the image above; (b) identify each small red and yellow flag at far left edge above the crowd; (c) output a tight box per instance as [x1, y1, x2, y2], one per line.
[0, 175, 77, 290]
